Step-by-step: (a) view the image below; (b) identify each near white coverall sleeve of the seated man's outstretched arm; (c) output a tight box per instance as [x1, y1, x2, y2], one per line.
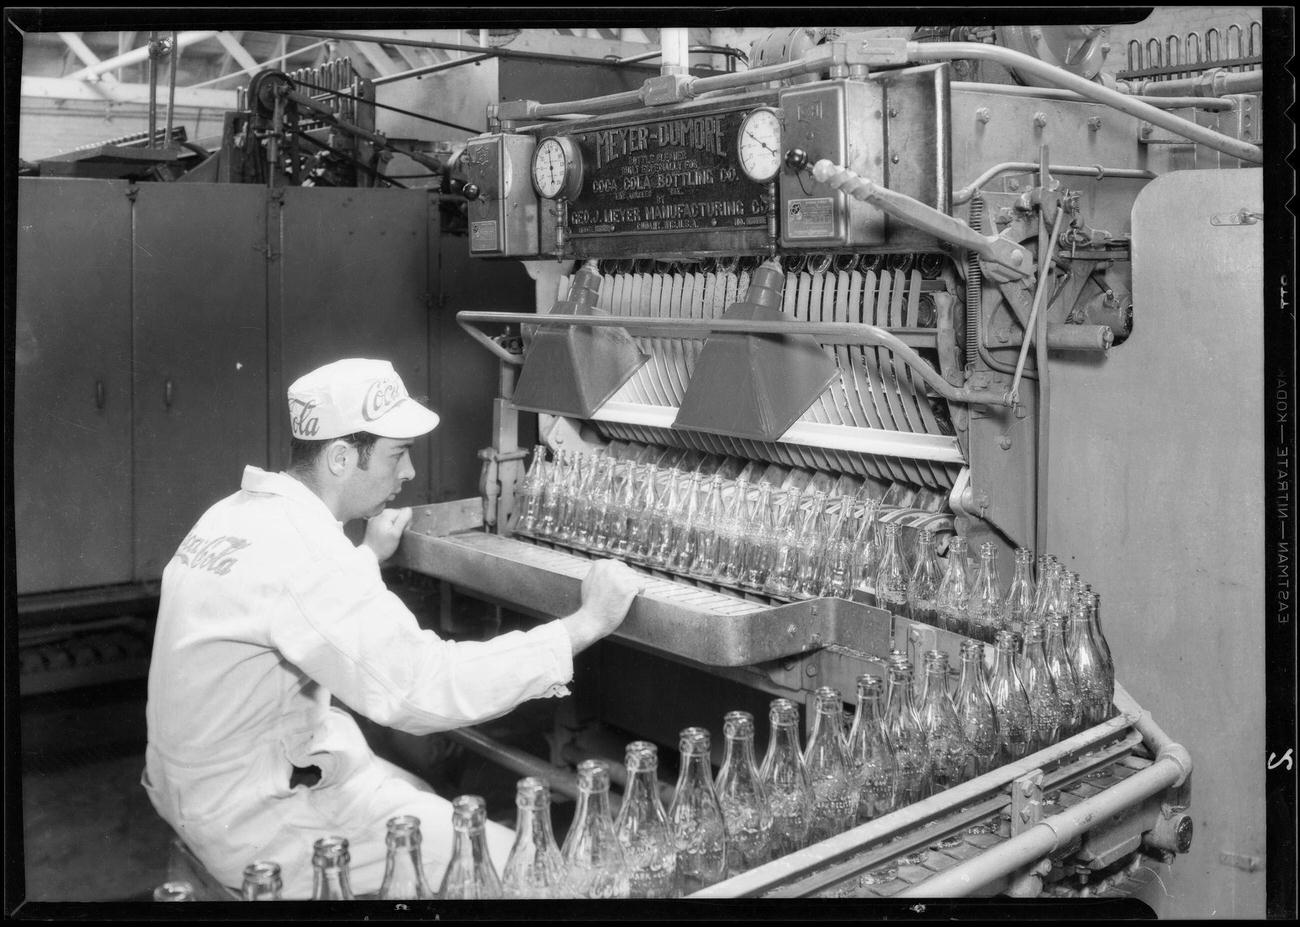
[270, 549, 573, 735]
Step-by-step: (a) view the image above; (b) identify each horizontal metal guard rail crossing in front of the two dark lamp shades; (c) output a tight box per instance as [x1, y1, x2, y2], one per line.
[456, 311, 1011, 406]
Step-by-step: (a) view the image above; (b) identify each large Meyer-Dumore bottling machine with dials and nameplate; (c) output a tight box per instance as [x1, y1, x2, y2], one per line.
[399, 23, 1262, 910]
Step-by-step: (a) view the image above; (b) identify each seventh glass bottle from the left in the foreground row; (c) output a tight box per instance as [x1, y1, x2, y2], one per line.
[560, 759, 631, 898]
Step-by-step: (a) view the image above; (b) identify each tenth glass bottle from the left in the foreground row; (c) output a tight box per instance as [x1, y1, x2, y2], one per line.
[718, 711, 772, 879]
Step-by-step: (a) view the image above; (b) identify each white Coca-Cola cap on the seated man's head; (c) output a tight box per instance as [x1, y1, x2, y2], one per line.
[289, 358, 438, 441]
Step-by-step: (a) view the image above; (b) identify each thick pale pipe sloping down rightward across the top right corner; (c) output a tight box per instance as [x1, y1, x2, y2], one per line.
[907, 42, 1264, 164]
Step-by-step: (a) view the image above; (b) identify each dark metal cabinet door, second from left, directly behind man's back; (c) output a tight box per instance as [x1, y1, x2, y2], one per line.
[131, 183, 268, 579]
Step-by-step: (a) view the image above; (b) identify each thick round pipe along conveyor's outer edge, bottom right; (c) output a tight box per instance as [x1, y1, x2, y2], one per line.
[894, 745, 1186, 898]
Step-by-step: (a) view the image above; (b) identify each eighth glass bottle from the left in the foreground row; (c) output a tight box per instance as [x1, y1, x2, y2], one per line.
[614, 740, 677, 898]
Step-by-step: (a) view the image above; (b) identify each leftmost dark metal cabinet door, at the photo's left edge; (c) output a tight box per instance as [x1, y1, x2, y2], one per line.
[13, 179, 133, 594]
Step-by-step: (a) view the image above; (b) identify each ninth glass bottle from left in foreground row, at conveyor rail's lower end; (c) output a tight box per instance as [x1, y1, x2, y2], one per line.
[668, 727, 727, 894]
